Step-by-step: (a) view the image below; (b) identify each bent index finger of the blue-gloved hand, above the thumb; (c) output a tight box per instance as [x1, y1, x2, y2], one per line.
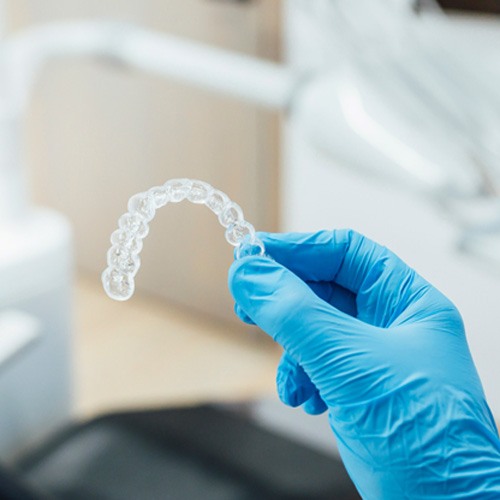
[259, 229, 428, 327]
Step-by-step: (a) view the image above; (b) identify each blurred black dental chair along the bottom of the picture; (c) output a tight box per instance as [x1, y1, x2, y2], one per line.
[0, 406, 359, 500]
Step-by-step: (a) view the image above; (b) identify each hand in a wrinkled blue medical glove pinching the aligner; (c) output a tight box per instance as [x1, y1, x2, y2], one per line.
[229, 230, 500, 499]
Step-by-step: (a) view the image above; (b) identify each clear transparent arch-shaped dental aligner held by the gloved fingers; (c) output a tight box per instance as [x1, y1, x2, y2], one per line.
[102, 179, 265, 300]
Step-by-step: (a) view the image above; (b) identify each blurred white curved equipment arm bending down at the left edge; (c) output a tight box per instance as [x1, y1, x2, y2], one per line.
[0, 21, 297, 223]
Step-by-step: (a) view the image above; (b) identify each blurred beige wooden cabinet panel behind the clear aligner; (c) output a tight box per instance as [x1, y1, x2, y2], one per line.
[8, 0, 280, 319]
